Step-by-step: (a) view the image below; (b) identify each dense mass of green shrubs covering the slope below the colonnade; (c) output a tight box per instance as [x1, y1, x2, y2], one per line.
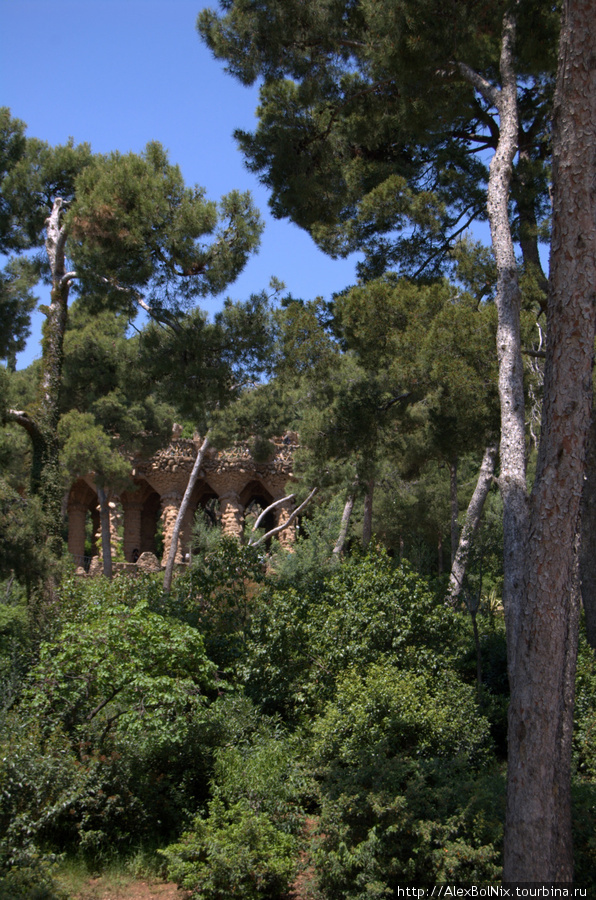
[0, 538, 596, 900]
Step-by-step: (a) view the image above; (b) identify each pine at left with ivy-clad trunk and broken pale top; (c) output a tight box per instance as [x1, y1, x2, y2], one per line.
[2, 122, 262, 554]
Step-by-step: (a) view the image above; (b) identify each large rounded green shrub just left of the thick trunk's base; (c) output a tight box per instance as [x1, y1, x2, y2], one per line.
[313, 663, 503, 900]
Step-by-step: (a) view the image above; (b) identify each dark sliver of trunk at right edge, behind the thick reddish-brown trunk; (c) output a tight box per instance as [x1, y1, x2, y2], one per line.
[579, 407, 596, 649]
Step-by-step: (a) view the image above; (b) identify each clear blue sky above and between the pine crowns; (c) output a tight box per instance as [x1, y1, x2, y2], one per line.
[0, 0, 364, 368]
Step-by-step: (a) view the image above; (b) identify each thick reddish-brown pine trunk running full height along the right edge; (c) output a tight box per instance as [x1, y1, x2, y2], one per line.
[503, 0, 596, 883]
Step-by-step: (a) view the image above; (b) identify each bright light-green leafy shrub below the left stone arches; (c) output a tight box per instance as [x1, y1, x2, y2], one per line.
[21, 577, 215, 753]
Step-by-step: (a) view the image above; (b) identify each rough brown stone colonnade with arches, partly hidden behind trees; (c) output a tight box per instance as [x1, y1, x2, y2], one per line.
[67, 433, 296, 571]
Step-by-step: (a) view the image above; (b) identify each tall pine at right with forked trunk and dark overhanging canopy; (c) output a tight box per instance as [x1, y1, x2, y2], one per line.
[199, 0, 596, 882]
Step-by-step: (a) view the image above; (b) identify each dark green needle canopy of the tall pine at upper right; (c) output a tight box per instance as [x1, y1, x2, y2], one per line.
[198, 0, 558, 277]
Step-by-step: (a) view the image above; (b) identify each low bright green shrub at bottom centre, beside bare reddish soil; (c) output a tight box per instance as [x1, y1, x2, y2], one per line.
[163, 701, 312, 900]
